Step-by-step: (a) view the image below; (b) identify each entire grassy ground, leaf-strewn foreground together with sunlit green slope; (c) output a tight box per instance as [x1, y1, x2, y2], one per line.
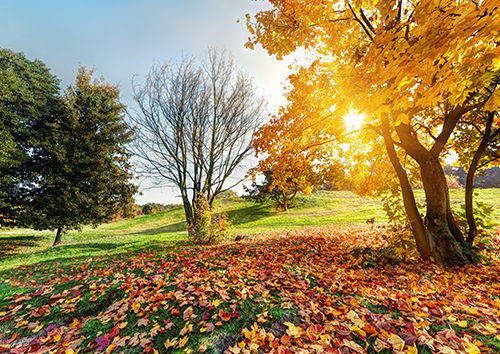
[0, 190, 500, 353]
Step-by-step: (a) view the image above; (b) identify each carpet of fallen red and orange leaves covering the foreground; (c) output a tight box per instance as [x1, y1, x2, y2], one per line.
[0, 198, 500, 354]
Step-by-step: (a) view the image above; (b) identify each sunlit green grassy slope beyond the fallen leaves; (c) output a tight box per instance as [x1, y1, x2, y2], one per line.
[0, 189, 500, 270]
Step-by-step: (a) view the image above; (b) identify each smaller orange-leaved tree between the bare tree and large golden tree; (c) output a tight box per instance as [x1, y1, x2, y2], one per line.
[249, 87, 358, 210]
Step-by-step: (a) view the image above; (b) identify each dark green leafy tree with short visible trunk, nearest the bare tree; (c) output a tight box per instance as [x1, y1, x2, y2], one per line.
[0, 59, 137, 245]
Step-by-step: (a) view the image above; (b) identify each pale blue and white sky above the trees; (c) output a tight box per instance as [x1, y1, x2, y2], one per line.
[0, 0, 300, 204]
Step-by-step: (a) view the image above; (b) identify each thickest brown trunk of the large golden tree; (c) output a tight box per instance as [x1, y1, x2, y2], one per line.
[396, 124, 469, 267]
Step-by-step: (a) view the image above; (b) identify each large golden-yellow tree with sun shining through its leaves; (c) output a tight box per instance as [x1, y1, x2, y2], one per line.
[247, 0, 500, 266]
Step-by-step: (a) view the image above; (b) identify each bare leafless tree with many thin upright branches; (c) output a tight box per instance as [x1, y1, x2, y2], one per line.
[132, 48, 265, 241]
